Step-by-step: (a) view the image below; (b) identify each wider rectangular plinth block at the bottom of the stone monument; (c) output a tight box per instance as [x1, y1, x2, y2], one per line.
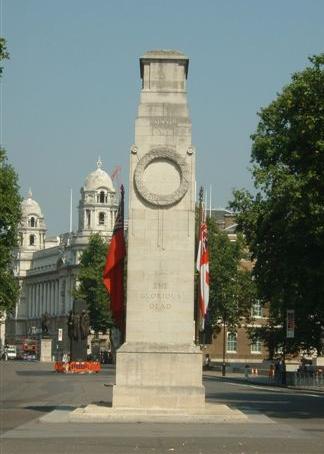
[113, 343, 205, 409]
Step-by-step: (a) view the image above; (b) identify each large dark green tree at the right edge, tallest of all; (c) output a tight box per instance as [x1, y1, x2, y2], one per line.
[230, 54, 324, 353]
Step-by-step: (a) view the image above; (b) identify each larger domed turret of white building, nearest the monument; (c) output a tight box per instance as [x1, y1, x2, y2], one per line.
[78, 158, 118, 238]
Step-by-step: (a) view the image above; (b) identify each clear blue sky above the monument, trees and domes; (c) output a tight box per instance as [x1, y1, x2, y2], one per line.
[1, 0, 324, 234]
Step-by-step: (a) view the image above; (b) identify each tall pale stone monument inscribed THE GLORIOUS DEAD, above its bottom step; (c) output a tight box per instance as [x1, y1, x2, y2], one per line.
[113, 50, 205, 409]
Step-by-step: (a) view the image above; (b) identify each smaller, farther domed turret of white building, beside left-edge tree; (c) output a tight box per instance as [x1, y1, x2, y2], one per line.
[19, 190, 46, 250]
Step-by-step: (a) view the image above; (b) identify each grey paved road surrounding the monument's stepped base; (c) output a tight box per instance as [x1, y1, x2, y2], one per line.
[0, 361, 324, 454]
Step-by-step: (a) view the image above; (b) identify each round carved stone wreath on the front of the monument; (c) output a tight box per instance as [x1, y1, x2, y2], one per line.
[134, 148, 189, 206]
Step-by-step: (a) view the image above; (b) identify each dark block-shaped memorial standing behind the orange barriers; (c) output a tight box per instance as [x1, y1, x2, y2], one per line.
[68, 301, 90, 361]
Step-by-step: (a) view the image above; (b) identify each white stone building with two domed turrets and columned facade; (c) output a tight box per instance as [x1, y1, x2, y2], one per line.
[6, 159, 118, 353]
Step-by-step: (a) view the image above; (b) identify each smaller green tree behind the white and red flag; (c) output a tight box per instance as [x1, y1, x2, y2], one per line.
[208, 218, 255, 331]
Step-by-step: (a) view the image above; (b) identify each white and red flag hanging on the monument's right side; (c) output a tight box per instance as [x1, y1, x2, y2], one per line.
[197, 215, 209, 329]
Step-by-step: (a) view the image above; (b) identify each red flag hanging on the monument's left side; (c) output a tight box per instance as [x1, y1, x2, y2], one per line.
[103, 186, 126, 332]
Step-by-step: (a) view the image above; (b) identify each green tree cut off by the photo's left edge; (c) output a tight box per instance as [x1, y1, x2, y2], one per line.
[0, 38, 21, 312]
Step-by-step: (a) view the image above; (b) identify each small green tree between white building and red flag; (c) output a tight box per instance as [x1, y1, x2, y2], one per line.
[74, 233, 113, 333]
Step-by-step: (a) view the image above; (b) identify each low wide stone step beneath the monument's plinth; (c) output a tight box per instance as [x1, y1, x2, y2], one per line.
[69, 403, 248, 423]
